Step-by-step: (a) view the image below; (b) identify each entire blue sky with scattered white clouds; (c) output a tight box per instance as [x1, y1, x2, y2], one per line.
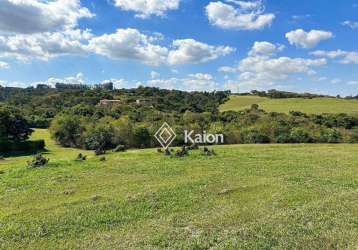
[0, 0, 358, 95]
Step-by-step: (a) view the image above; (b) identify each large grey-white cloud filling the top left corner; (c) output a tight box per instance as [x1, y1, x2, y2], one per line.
[0, 0, 94, 34]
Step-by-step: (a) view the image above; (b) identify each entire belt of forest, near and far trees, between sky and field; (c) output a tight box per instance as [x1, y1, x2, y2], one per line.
[0, 85, 358, 153]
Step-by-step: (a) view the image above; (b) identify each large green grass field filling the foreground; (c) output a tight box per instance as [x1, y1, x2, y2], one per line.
[0, 130, 358, 249]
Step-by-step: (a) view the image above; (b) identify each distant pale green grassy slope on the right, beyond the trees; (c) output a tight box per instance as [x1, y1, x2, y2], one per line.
[220, 96, 358, 114]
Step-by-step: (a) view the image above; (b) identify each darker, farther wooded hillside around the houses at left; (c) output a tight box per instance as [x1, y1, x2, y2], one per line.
[0, 87, 229, 128]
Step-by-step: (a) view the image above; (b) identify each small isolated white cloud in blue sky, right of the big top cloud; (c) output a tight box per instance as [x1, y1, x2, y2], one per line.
[286, 29, 333, 49]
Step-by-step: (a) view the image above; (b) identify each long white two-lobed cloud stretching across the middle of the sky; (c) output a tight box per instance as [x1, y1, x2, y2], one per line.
[89, 29, 234, 66]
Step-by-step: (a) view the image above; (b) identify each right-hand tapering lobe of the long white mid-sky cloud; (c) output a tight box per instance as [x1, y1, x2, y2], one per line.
[168, 39, 235, 65]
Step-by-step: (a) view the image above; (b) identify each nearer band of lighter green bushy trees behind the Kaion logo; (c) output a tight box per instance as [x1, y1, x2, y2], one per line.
[50, 104, 358, 152]
